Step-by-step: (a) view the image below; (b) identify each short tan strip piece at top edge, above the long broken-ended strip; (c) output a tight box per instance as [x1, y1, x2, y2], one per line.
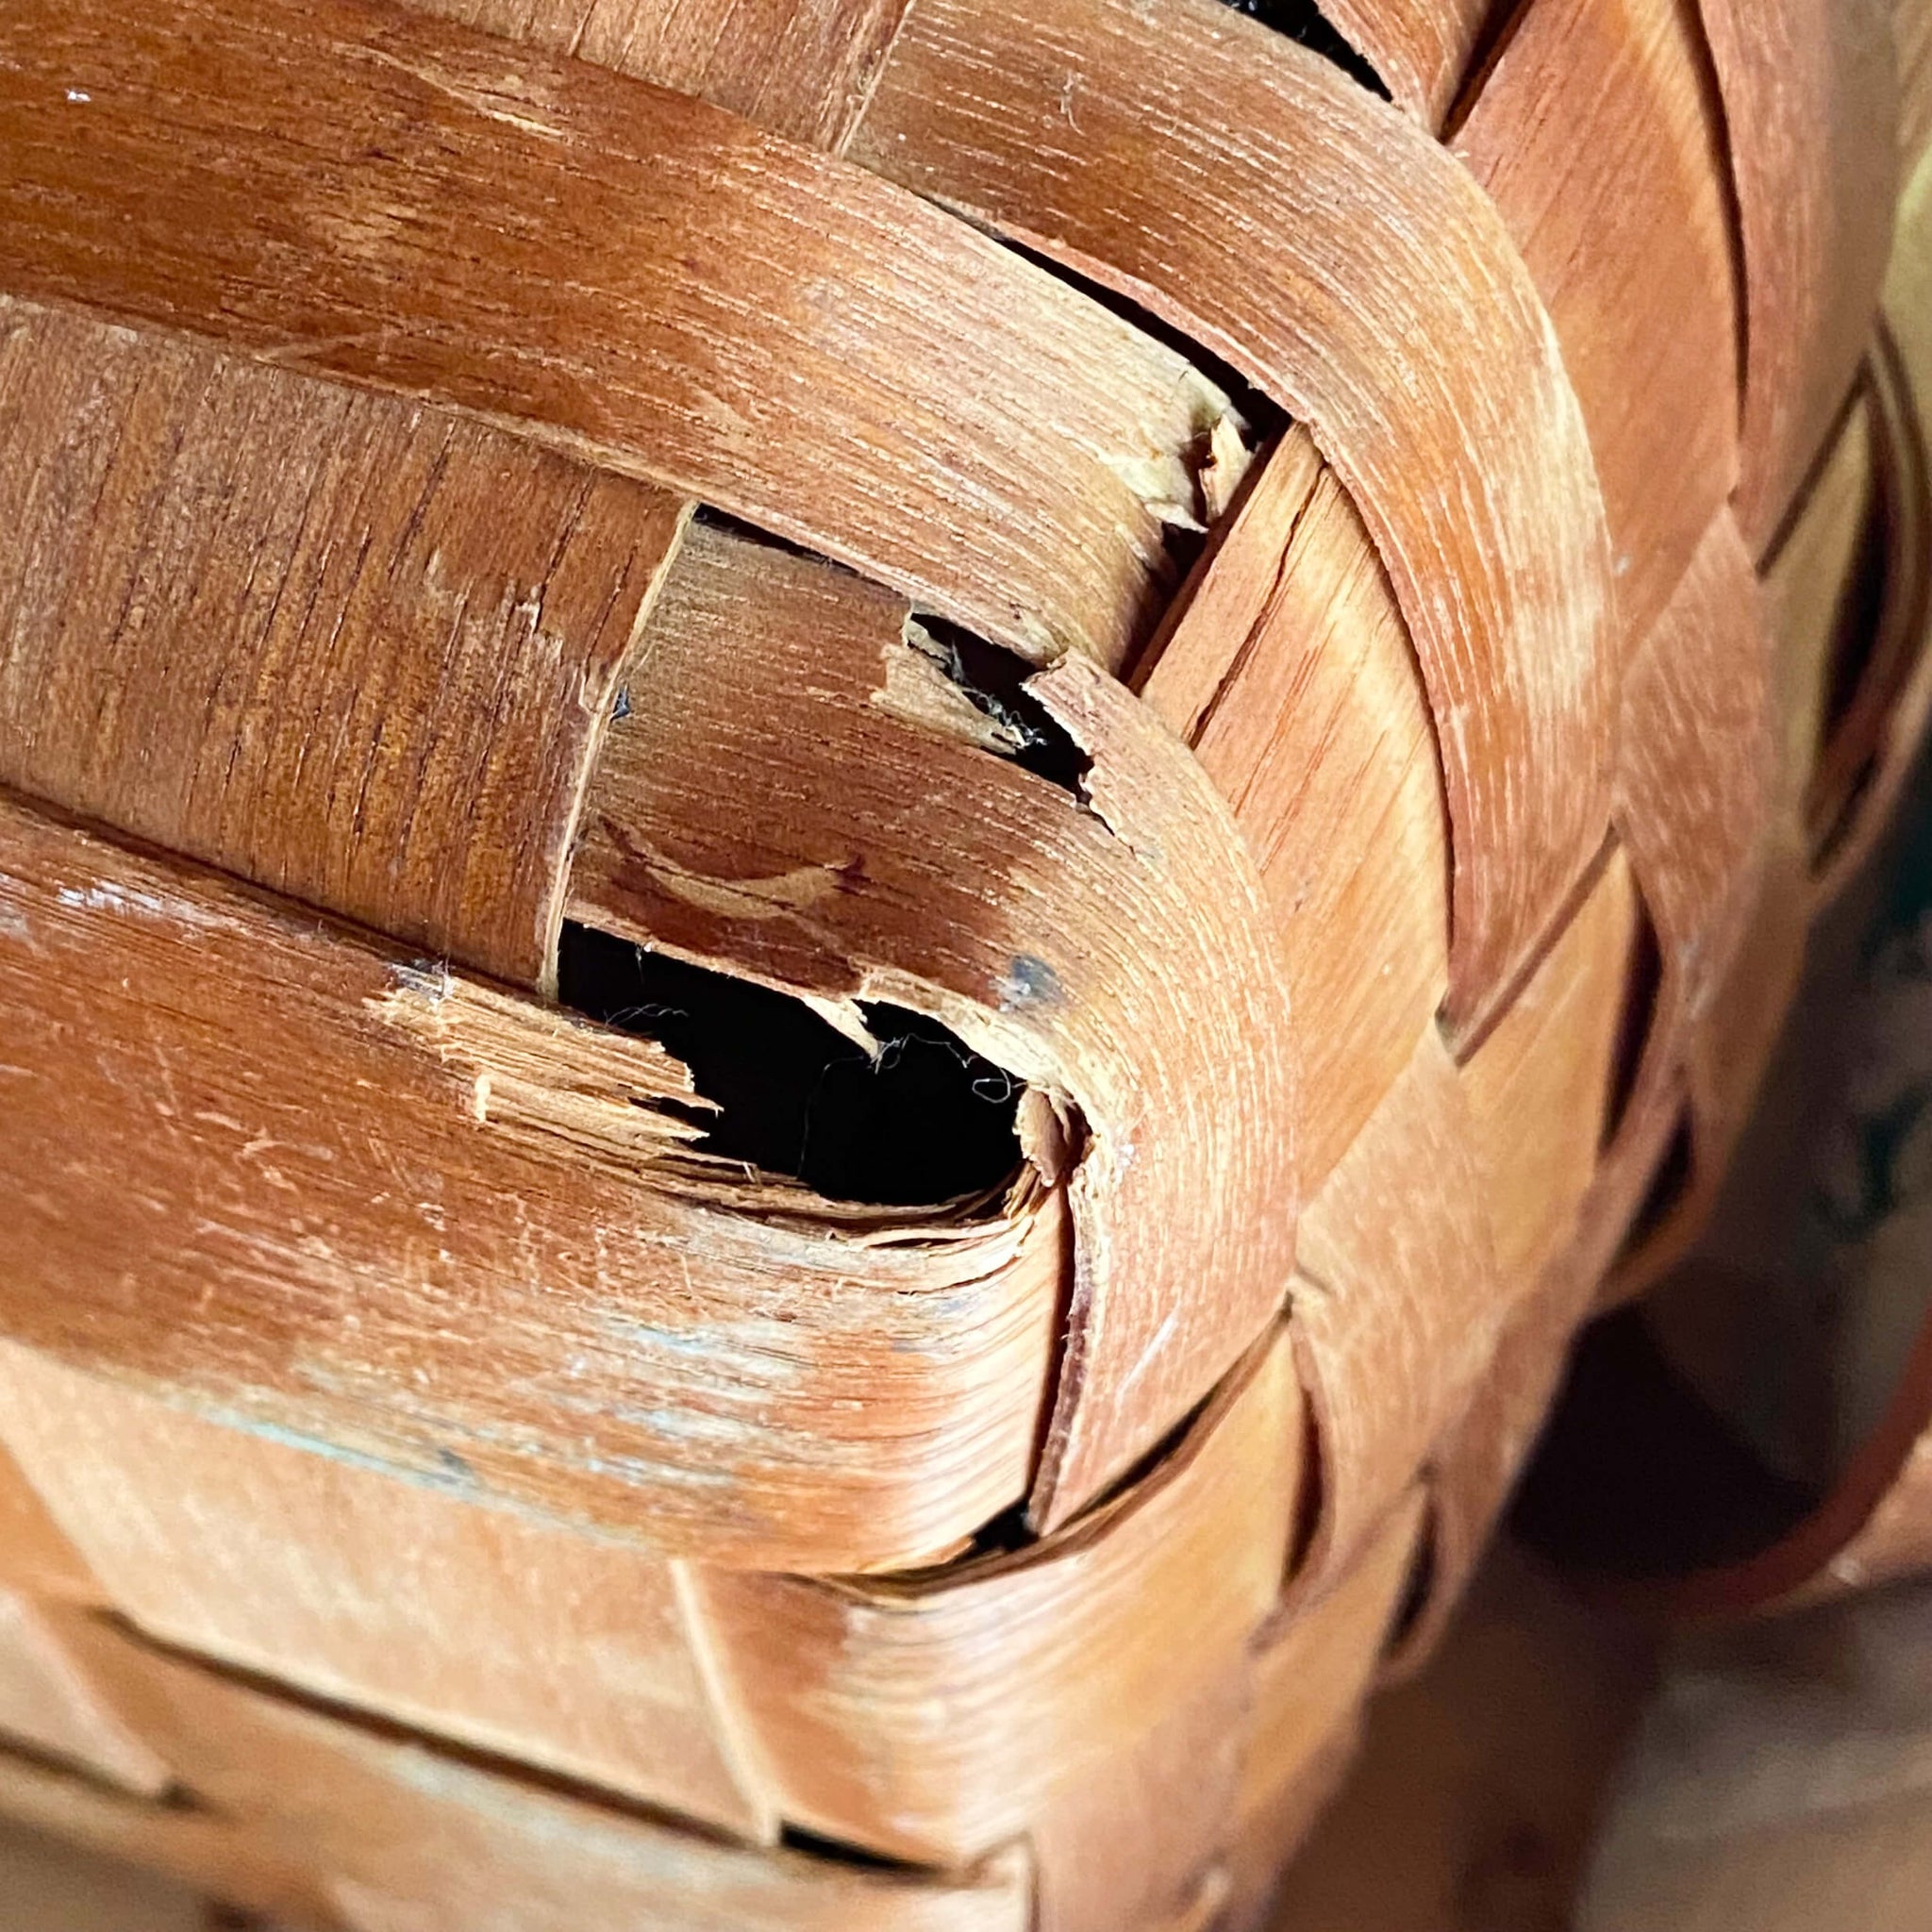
[404, 0, 910, 155]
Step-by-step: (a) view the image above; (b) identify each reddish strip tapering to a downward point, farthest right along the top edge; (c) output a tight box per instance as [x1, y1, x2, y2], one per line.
[1700, 0, 1899, 558]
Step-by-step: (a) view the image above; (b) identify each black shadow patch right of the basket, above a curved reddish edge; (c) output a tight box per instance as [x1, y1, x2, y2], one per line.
[1511, 1307, 1822, 1580]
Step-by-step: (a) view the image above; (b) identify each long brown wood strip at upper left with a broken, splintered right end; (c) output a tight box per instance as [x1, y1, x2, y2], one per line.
[0, 0, 1226, 665]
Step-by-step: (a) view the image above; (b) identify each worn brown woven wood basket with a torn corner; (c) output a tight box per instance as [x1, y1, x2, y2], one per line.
[0, 0, 1932, 1932]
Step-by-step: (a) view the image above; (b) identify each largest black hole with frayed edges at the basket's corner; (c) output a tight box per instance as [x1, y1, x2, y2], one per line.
[558, 924, 1020, 1208]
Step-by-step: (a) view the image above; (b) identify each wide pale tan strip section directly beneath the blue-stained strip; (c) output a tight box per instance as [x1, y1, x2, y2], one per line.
[0, 1342, 776, 1843]
